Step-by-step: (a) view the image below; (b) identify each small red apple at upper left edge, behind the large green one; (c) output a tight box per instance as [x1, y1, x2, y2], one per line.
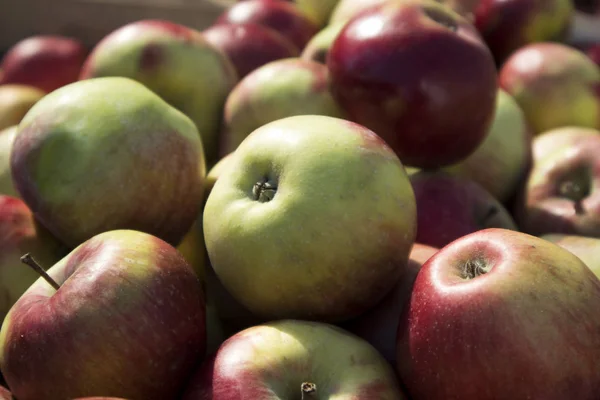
[0, 35, 87, 93]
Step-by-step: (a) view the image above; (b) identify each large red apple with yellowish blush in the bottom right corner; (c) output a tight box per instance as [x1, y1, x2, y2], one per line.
[397, 229, 600, 400]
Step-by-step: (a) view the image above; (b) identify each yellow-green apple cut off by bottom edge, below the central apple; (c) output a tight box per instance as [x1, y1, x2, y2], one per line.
[183, 320, 406, 400]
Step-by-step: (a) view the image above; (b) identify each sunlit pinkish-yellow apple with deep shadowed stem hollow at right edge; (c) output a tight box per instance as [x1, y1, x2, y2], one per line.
[516, 128, 600, 237]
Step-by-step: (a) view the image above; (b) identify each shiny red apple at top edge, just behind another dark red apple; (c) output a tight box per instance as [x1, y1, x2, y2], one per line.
[216, 0, 319, 50]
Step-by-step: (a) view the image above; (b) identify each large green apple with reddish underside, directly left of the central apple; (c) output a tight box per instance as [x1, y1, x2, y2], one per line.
[11, 77, 205, 248]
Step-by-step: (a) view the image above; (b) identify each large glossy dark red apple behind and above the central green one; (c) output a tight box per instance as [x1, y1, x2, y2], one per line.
[327, 0, 497, 168]
